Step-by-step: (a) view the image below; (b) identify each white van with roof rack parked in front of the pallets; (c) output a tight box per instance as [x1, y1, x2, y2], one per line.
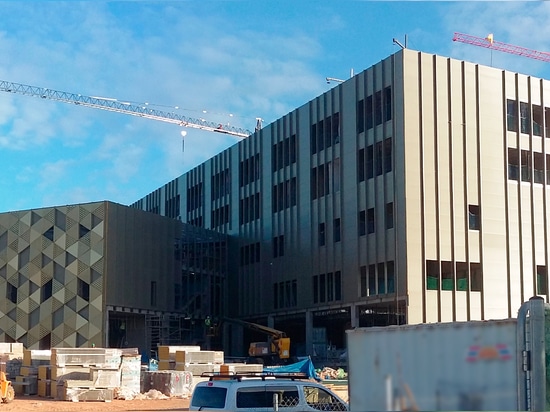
[189, 374, 348, 412]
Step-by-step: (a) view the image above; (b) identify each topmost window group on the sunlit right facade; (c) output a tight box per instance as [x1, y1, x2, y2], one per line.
[506, 99, 550, 137]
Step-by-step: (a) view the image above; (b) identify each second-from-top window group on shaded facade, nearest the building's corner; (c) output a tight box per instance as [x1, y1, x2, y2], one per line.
[357, 137, 393, 182]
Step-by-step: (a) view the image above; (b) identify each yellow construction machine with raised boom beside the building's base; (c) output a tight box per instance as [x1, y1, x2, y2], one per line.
[223, 318, 290, 364]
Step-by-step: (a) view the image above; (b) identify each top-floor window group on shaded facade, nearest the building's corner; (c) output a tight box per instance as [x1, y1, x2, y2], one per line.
[357, 86, 392, 133]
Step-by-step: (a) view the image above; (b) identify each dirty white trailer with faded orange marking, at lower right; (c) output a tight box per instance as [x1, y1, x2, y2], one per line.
[347, 297, 550, 411]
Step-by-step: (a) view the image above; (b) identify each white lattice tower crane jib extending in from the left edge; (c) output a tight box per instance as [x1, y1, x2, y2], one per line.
[0, 80, 262, 138]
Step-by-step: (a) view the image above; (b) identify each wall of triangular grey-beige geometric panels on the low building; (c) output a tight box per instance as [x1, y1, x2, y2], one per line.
[0, 202, 106, 349]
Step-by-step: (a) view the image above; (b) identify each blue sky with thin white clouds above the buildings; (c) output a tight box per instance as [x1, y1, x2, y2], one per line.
[0, 0, 550, 212]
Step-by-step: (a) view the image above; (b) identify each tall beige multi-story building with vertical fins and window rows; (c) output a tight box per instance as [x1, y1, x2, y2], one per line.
[132, 49, 550, 353]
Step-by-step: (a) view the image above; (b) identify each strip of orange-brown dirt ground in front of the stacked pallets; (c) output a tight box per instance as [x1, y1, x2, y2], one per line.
[0, 396, 189, 412]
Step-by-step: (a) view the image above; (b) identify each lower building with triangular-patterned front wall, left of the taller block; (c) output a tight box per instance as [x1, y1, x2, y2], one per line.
[0, 202, 228, 355]
